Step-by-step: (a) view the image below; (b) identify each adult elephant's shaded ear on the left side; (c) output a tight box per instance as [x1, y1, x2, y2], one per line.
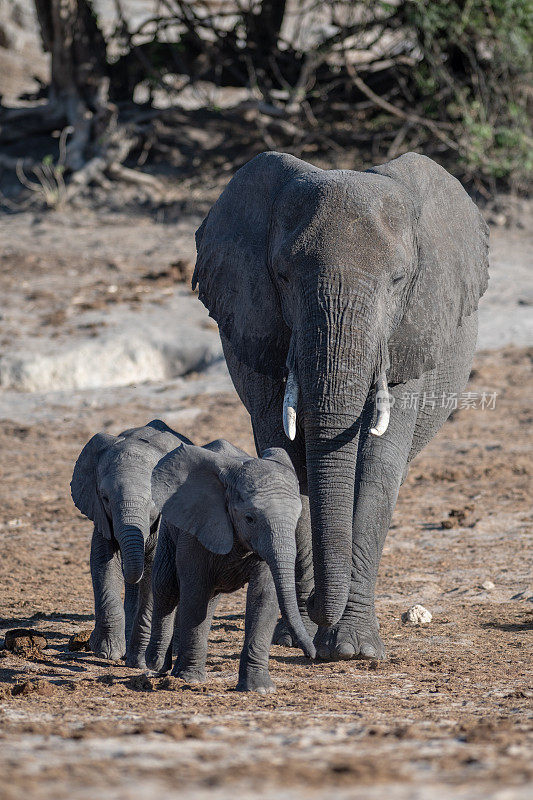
[192, 152, 314, 378]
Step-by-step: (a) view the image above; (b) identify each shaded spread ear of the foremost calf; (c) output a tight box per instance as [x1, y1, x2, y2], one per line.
[152, 444, 233, 554]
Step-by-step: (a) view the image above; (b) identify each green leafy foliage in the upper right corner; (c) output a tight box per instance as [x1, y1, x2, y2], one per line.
[395, 0, 533, 188]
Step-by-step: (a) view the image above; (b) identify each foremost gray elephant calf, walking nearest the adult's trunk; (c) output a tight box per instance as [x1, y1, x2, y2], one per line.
[146, 439, 315, 692]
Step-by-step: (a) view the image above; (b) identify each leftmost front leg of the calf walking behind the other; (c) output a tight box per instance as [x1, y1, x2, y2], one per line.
[89, 527, 126, 661]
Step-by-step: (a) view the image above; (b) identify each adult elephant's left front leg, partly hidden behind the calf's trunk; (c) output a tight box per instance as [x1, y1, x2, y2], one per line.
[272, 494, 317, 648]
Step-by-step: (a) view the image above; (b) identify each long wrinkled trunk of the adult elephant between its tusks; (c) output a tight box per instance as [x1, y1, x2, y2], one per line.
[295, 273, 384, 626]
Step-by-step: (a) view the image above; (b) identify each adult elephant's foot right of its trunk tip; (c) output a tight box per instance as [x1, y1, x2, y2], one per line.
[315, 619, 385, 661]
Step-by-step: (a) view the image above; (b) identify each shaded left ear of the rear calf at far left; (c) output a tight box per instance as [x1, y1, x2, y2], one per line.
[70, 433, 117, 539]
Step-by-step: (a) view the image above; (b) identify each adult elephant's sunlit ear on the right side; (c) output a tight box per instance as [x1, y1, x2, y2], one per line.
[371, 153, 488, 383]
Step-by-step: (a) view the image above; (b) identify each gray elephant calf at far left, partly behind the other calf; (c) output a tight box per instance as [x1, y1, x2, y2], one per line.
[71, 419, 189, 668]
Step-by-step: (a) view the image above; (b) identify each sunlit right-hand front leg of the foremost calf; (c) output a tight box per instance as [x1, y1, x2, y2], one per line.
[237, 561, 278, 694]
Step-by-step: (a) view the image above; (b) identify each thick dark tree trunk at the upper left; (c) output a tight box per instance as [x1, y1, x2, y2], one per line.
[35, 0, 111, 170]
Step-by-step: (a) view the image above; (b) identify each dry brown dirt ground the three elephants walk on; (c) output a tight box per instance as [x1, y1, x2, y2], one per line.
[0, 216, 533, 800]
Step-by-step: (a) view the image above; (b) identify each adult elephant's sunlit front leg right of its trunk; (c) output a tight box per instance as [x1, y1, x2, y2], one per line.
[315, 382, 417, 659]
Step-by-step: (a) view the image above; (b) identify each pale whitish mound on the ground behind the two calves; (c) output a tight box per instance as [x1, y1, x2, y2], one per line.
[0, 286, 222, 392]
